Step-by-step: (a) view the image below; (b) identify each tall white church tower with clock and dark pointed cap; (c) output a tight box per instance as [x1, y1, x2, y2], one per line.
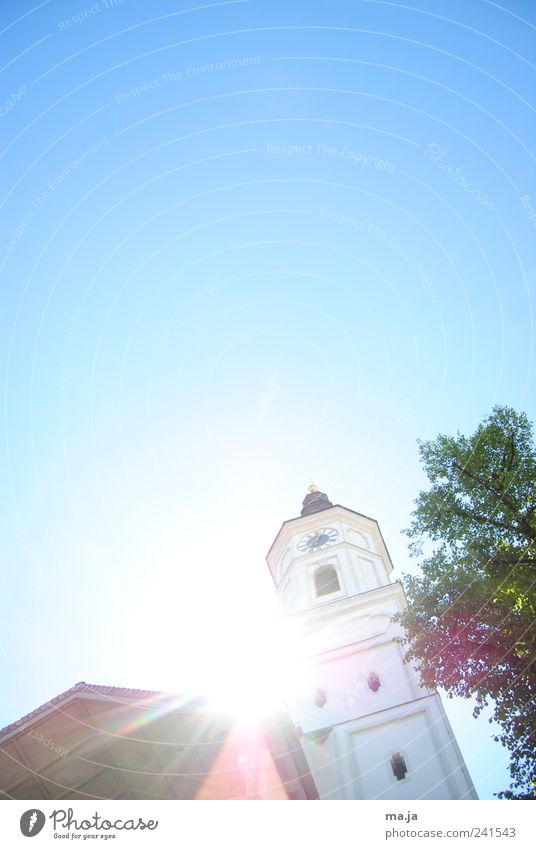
[267, 486, 477, 800]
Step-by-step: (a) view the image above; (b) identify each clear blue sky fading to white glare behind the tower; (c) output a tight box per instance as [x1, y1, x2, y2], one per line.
[0, 0, 536, 798]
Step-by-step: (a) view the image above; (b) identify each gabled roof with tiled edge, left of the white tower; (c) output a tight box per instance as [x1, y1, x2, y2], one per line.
[0, 681, 318, 799]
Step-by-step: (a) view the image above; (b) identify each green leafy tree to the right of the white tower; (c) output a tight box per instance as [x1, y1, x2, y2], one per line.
[397, 407, 536, 799]
